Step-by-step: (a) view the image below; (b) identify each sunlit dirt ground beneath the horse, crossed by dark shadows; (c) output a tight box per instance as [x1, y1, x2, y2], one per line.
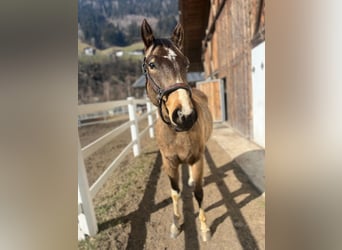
[78, 120, 265, 250]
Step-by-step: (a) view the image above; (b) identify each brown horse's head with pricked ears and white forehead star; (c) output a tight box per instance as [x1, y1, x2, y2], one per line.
[141, 20, 197, 132]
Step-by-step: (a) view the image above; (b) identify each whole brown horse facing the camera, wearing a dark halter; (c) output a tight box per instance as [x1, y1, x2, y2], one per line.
[141, 19, 213, 241]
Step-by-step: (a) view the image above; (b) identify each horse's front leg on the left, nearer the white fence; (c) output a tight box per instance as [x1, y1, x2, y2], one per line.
[163, 156, 181, 238]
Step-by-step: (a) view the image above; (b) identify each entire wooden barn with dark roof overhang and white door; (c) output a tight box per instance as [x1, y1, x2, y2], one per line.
[179, 0, 265, 147]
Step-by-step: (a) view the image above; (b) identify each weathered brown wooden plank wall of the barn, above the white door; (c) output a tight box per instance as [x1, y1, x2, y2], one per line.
[202, 0, 265, 138]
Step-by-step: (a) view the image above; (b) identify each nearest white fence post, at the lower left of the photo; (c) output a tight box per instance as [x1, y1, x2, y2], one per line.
[78, 139, 98, 239]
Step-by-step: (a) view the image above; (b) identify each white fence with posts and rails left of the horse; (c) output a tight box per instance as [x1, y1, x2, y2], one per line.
[78, 97, 155, 240]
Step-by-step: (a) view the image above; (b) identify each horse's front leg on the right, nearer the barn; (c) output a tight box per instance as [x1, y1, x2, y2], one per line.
[189, 157, 211, 241]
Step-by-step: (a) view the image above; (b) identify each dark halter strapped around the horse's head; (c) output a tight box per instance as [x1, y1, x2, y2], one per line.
[142, 57, 192, 126]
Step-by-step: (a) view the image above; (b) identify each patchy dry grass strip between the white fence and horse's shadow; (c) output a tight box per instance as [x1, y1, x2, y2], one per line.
[78, 139, 158, 250]
